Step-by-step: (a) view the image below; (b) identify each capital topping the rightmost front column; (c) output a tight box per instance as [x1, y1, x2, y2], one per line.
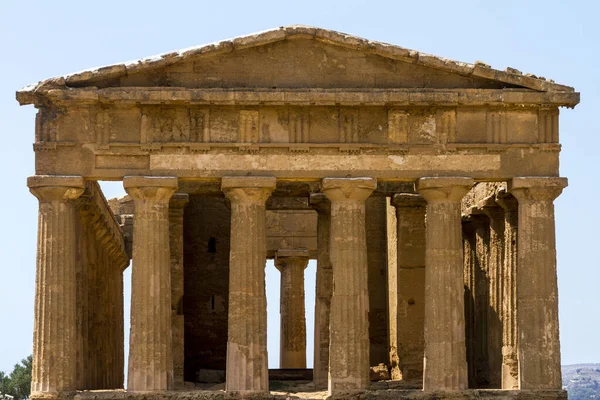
[508, 177, 568, 202]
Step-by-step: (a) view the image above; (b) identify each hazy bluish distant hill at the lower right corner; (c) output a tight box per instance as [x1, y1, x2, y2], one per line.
[562, 364, 600, 400]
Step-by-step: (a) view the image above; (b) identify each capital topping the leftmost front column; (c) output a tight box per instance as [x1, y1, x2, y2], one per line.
[27, 175, 85, 201]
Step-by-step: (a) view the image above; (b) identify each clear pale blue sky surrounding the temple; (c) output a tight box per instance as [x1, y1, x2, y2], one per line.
[0, 0, 600, 371]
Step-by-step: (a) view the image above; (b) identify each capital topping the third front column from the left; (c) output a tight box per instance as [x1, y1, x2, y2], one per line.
[221, 176, 277, 204]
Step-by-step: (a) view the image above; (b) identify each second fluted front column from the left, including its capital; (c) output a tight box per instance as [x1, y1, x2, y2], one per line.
[123, 176, 177, 391]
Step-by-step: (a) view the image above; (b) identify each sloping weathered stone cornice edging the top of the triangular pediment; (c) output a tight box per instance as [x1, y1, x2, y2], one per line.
[17, 25, 575, 105]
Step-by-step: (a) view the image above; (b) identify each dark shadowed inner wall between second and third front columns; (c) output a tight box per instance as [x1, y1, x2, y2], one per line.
[183, 195, 231, 382]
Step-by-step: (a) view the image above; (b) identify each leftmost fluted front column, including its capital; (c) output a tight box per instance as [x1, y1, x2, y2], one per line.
[27, 175, 84, 398]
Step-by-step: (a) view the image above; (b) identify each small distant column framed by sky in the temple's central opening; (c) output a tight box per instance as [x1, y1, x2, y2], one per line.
[275, 249, 309, 368]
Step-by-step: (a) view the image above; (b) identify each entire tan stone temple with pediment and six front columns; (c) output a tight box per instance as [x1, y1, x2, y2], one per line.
[17, 26, 579, 399]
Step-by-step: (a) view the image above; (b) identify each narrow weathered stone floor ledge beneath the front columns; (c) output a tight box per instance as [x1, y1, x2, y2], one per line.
[69, 390, 567, 400]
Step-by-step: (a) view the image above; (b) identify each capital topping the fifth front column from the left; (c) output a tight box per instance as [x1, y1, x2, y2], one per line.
[417, 176, 475, 203]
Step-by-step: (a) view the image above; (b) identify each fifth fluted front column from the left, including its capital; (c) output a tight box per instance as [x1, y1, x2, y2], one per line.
[417, 177, 474, 390]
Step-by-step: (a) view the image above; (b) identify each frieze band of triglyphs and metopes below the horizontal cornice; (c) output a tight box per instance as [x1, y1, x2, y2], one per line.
[35, 105, 558, 153]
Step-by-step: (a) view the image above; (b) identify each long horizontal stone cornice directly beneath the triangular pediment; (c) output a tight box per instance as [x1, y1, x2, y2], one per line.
[38, 87, 580, 107]
